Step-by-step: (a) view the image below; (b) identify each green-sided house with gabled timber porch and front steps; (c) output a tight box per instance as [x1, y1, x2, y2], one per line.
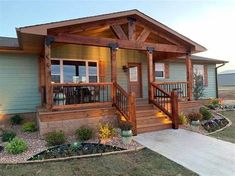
[0, 10, 228, 134]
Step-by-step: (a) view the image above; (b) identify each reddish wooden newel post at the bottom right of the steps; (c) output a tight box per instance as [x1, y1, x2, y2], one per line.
[171, 91, 179, 129]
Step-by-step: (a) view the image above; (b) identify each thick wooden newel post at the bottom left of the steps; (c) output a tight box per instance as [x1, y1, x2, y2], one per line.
[128, 92, 137, 136]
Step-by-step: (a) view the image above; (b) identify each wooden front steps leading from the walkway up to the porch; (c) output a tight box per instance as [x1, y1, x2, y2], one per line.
[136, 99, 172, 134]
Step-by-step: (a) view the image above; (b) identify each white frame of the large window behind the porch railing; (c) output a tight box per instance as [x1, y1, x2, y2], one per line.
[51, 58, 100, 83]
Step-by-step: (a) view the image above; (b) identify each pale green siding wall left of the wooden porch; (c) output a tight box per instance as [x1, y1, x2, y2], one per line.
[0, 54, 40, 114]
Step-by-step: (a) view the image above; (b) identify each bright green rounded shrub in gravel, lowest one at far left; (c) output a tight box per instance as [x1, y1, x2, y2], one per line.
[5, 137, 28, 155]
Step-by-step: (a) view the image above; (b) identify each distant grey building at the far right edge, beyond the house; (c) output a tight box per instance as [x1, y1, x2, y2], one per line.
[218, 70, 235, 87]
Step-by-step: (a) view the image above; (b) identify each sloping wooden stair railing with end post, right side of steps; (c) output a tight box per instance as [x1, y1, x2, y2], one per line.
[151, 83, 179, 129]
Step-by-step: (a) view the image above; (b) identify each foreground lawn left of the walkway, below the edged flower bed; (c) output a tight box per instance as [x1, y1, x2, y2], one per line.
[0, 149, 196, 176]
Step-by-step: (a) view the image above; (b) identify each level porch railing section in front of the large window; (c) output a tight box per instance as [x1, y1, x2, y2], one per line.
[52, 82, 112, 106]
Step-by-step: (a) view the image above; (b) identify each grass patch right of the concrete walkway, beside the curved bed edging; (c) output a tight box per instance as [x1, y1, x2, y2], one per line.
[210, 111, 235, 143]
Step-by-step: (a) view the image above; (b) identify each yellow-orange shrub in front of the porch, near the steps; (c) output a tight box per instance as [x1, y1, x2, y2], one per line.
[99, 123, 115, 139]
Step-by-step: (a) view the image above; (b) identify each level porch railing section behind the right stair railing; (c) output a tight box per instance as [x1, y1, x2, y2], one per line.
[156, 82, 187, 99]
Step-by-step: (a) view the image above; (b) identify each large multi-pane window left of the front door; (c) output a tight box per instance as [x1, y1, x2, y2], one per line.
[51, 59, 98, 83]
